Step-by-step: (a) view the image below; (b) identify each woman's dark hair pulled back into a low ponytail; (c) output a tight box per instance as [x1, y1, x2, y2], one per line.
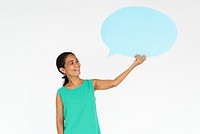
[56, 52, 74, 86]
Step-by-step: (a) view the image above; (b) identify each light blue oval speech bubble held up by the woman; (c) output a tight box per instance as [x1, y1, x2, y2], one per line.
[101, 6, 177, 57]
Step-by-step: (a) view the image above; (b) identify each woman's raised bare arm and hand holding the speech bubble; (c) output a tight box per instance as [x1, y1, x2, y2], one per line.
[92, 55, 146, 90]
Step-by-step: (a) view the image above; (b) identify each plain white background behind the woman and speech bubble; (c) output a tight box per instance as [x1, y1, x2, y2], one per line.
[0, 0, 200, 134]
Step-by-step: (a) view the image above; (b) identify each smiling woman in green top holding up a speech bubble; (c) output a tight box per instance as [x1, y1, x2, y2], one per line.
[56, 52, 146, 134]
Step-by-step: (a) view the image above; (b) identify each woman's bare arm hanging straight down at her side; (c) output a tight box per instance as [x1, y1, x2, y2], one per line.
[56, 93, 64, 134]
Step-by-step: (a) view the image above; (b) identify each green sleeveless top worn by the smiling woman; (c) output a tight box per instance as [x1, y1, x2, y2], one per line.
[58, 80, 101, 134]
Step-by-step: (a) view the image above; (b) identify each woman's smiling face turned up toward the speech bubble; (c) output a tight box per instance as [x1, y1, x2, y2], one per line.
[62, 54, 81, 77]
